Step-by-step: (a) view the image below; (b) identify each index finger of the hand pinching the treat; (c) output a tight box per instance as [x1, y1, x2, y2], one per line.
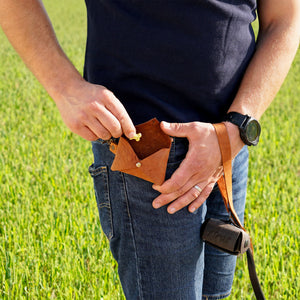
[105, 91, 136, 139]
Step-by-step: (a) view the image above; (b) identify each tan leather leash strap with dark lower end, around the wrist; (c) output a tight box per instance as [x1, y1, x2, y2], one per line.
[213, 123, 265, 300]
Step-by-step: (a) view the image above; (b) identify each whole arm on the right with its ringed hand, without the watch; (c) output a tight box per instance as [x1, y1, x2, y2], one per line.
[153, 0, 300, 213]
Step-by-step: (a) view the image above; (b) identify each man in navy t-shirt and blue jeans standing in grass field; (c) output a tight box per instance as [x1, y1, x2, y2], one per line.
[0, 0, 300, 299]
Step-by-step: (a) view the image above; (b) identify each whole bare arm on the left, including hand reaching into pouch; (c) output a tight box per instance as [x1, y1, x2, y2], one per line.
[0, 0, 135, 140]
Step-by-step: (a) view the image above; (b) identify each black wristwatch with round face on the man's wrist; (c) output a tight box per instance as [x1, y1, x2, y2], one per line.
[224, 112, 261, 146]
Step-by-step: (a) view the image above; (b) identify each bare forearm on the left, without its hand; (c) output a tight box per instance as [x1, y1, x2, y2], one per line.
[0, 0, 82, 99]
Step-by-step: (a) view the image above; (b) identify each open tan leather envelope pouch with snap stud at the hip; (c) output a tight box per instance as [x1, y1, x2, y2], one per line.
[110, 119, 172, 185]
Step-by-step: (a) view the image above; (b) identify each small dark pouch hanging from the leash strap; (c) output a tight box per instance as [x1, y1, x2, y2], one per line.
[200, 218, 251, 255]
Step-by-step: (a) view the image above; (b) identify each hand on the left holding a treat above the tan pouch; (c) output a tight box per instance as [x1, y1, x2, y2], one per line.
[54, 80, 136, 141]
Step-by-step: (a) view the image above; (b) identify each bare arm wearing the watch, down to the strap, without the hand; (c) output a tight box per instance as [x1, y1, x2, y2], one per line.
[226, 0, 300, 157]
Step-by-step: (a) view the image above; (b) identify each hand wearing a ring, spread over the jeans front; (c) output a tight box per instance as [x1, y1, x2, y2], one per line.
[152, 122, 223, 214]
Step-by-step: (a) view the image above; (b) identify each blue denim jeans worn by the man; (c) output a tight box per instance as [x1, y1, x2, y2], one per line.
[89, 138, 248, 300]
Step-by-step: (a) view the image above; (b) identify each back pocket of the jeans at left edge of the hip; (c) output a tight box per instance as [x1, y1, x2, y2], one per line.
[89, 164, 113, 240]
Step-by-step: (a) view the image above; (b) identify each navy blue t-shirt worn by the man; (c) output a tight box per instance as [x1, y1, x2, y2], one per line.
[84, 0, 256, 124]
